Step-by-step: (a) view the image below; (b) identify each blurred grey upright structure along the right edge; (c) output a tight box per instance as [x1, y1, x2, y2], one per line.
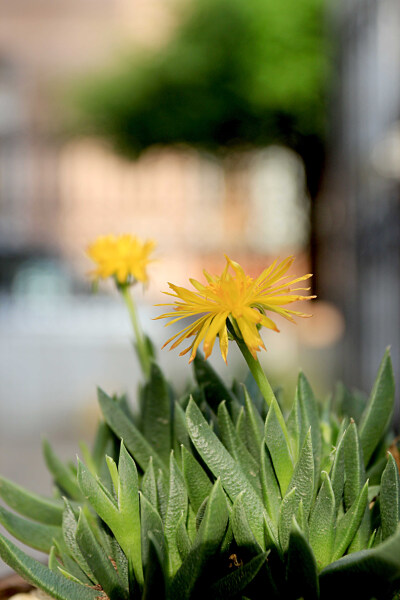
[317, 0, 400, 408]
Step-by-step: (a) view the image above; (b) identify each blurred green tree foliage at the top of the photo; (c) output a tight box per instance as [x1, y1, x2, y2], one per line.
[72, 0, 327, 165]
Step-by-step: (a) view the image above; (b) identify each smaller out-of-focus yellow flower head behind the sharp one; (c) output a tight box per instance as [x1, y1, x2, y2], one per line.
[87, 234, 155, 285]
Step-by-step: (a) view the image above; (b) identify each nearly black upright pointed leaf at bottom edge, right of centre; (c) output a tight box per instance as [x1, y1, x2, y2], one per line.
[285, 519, 319, 600]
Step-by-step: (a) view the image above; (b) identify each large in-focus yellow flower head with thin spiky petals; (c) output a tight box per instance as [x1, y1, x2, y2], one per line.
[157, 256, 315, 362]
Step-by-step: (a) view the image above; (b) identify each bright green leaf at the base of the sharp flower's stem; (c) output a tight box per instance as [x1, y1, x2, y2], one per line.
[265, 400, 293, 495]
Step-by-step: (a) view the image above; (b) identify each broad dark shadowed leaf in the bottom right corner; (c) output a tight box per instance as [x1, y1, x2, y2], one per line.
[320, 527, 400, 600]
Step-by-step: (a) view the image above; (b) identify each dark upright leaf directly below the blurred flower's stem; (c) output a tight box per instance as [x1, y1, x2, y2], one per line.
[142, 362, 172, 466]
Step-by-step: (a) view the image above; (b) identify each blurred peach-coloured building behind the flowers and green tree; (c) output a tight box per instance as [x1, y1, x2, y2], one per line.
[0, 0, 309, 287]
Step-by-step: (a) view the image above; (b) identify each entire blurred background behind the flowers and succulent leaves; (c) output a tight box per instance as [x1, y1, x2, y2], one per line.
[0, 0, 400, 572]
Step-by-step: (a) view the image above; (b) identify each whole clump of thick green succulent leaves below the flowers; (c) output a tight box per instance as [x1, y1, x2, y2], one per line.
[0, 353, 400, 600]
